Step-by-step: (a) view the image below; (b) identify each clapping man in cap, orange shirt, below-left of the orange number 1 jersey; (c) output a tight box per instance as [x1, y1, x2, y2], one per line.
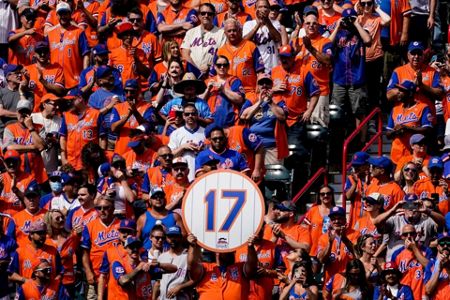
[25, 41, 66, 112]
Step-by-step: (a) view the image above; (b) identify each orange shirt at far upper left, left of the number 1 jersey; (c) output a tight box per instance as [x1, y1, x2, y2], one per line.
[8, 28, 44, 66]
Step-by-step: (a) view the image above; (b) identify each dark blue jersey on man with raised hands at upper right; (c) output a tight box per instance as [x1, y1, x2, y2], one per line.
[333, 29, 366, 86]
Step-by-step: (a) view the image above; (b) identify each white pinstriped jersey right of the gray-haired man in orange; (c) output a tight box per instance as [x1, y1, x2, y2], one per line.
[242, 20, 281, 73]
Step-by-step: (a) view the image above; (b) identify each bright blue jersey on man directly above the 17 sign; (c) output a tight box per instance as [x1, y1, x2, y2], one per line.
[195, 148, 249, 172]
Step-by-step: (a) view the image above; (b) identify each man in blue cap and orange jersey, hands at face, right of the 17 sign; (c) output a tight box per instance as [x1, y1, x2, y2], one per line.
[317, 206, 359, 282]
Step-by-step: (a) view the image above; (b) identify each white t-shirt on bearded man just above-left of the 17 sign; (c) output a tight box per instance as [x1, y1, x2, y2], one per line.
[168, 126, 205, 181]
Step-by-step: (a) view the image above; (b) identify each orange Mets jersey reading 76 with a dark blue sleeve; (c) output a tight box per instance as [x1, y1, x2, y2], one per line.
[272, 60, 320, 126]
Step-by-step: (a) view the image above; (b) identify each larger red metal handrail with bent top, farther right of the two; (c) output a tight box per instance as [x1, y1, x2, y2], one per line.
[342, 108, 383, 209]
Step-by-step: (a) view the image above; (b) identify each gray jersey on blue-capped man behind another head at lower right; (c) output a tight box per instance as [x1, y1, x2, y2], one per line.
[383, 215, 438, 261]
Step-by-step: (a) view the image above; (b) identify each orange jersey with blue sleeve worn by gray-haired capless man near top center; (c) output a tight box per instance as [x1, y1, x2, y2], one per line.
[216, 40, 264, 93]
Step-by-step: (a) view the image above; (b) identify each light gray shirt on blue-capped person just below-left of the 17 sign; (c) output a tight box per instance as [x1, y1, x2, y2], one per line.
[158, 249, 191, 300]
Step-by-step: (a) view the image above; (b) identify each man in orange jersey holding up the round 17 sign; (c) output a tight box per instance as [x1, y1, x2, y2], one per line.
[187, 234, 258, 300]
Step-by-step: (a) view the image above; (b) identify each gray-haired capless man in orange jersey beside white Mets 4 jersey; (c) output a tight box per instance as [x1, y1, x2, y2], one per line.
[214, 19, 264, 102]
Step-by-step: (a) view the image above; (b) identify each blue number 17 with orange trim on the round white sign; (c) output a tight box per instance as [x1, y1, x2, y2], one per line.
[205, 190, 246, 231]
